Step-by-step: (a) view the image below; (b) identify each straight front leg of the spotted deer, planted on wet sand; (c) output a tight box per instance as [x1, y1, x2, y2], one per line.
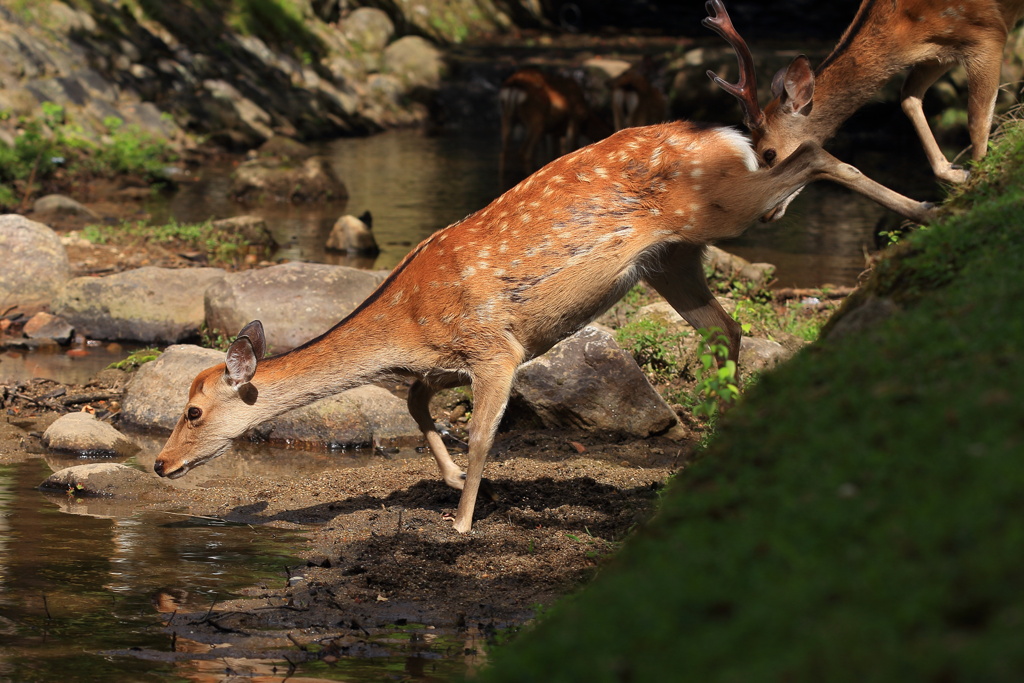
[455, 355, 521, 533]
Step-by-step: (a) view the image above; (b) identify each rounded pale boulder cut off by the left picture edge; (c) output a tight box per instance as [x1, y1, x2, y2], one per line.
[0, 214, 72, 308]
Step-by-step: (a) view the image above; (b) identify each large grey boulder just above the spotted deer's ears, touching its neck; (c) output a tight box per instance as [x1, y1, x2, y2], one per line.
[206, 262, 384, 353]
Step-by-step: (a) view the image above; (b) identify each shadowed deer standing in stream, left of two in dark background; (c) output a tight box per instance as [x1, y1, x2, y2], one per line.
[498, 67, 611, 176]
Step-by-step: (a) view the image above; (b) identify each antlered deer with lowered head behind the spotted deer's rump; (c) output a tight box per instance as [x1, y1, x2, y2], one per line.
[733, 0, 1024, 182]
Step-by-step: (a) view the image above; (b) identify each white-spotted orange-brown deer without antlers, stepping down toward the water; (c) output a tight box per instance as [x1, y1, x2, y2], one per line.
[155, 3, 933, 532]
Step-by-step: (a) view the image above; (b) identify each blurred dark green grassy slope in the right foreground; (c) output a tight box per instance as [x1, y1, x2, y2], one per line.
[478, 120, 1024, 683]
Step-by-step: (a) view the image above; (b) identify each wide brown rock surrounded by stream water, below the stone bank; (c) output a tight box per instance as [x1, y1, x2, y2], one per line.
[230, 157, 348, 202]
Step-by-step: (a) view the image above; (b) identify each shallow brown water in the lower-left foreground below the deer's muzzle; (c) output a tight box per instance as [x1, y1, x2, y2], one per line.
[0, 453, 478, 682]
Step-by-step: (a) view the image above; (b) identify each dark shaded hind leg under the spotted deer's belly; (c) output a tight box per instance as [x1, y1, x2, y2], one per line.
[645, 245, 742, 361]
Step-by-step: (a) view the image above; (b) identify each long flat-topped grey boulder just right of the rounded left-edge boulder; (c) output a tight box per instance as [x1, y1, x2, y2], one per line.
[53, 266, 225, 343]
